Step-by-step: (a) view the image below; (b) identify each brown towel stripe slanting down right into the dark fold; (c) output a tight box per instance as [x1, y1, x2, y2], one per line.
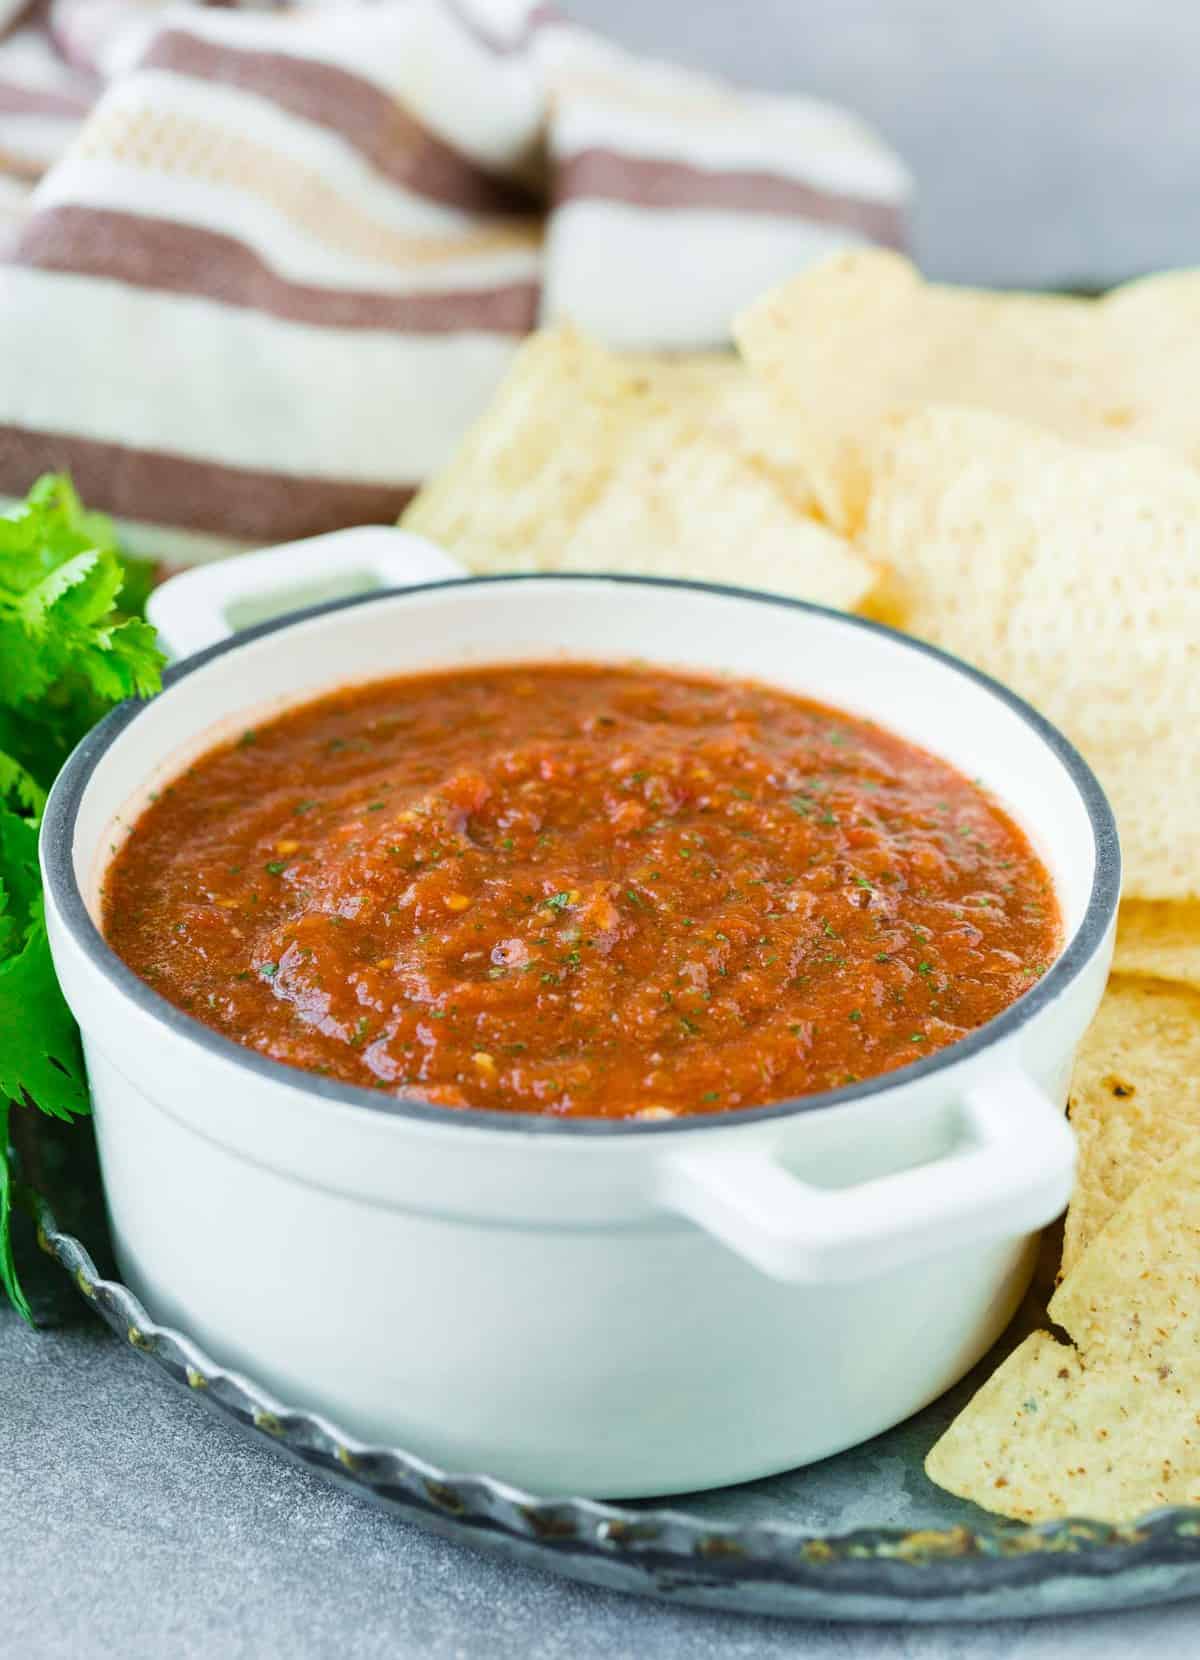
[141, 28, 539, 214]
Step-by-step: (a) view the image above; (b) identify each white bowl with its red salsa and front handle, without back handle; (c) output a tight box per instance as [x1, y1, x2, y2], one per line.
[43, 533, 1119, 1496]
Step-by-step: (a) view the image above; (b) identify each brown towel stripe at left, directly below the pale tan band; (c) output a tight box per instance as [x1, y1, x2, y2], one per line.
[7, 206, 538, 334]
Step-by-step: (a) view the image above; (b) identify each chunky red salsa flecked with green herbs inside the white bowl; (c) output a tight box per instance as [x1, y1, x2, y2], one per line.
[105, 664, 1061, 1117]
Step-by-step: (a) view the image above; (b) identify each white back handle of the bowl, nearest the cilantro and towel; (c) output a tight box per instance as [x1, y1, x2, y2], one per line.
[146, 525, 466, 657]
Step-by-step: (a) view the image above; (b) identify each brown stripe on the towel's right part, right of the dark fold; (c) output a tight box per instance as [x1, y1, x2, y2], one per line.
[554, 148, 905, 247]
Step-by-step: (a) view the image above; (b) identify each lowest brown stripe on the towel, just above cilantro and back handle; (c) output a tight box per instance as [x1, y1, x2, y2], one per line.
[0, 425, 413, 543]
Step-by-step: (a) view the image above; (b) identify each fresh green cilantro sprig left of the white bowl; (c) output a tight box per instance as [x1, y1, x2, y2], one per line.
[0, 475, 164, 1320]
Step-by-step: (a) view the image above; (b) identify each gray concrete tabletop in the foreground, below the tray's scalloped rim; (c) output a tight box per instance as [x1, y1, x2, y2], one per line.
[0, 1316, 1197, 1660]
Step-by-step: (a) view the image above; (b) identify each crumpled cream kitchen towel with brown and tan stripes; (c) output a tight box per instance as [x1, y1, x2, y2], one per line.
[0, 0, 908, 563]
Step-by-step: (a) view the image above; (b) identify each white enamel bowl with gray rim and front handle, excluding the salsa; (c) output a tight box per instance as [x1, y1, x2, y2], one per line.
[41, 534, 1119, 1497]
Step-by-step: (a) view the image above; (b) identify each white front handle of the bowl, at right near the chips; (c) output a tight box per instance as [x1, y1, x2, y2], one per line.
[662, 1069, 1076, 1280]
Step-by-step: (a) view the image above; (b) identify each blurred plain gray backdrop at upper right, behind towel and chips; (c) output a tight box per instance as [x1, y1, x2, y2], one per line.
[564, 0, 1200, 287]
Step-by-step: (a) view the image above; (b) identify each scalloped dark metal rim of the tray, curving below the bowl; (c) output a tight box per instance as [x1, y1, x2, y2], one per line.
[38, 1204, 1200, 1622]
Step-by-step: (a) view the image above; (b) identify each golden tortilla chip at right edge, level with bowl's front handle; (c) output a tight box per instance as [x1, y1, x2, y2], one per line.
[1062, 978, 1200, 1275]
